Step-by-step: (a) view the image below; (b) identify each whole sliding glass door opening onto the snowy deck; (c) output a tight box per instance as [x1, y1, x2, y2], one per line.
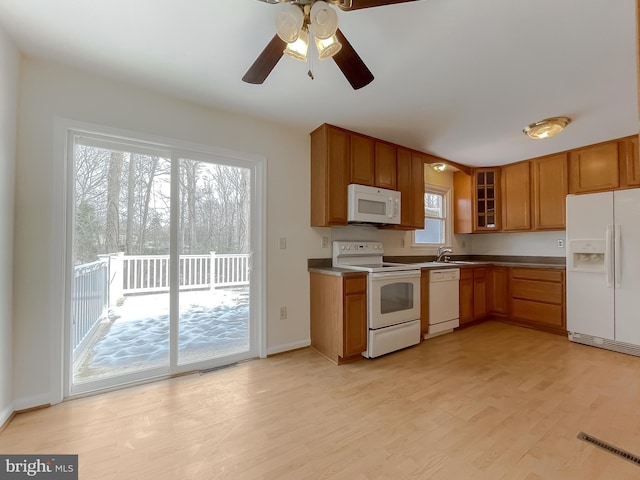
[66, 132, 258, 395]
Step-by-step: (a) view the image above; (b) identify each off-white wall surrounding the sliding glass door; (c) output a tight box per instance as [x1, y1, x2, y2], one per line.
[15, 59, 330, 408]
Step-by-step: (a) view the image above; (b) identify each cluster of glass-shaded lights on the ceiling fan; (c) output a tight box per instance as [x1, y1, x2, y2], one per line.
[276, 0, 342, 62]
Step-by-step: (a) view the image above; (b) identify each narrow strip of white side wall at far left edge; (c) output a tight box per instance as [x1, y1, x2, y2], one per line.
[0, 27, 20, 425]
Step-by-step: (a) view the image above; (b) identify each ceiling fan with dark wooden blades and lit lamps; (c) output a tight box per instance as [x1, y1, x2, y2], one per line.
[242, 0, 416, 90]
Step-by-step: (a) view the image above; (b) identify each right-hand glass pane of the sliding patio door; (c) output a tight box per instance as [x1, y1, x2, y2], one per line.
[178, 159, 251, 365]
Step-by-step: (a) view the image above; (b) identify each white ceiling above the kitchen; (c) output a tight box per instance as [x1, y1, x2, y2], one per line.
[0, 0, 640, 165]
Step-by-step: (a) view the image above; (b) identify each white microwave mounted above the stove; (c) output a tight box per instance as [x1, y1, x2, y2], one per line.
[347, 183, 400, 225]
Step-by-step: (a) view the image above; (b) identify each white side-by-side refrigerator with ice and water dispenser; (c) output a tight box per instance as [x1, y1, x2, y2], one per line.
[566, 188, 640, 355]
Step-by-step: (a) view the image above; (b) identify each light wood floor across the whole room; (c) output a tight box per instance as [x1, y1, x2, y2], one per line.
[0, 322, 640, 480]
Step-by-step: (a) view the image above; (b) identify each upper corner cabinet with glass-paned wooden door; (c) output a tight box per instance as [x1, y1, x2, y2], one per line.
[472, 167, 501, 232]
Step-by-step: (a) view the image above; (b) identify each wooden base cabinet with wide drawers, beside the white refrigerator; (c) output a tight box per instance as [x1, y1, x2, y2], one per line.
[509, 267, 566, 334]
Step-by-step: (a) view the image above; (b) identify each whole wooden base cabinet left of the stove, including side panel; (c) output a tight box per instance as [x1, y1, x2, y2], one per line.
[309, 272, 367, 363]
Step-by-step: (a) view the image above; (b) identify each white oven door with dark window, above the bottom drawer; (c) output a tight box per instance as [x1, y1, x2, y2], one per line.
[368, 270, 420, 329]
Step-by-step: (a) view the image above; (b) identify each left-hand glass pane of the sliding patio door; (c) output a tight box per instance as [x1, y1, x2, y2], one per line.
[70, 138, 170, 392]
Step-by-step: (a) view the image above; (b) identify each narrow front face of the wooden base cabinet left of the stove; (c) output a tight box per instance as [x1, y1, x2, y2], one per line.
[342, 276, 367, 358]
